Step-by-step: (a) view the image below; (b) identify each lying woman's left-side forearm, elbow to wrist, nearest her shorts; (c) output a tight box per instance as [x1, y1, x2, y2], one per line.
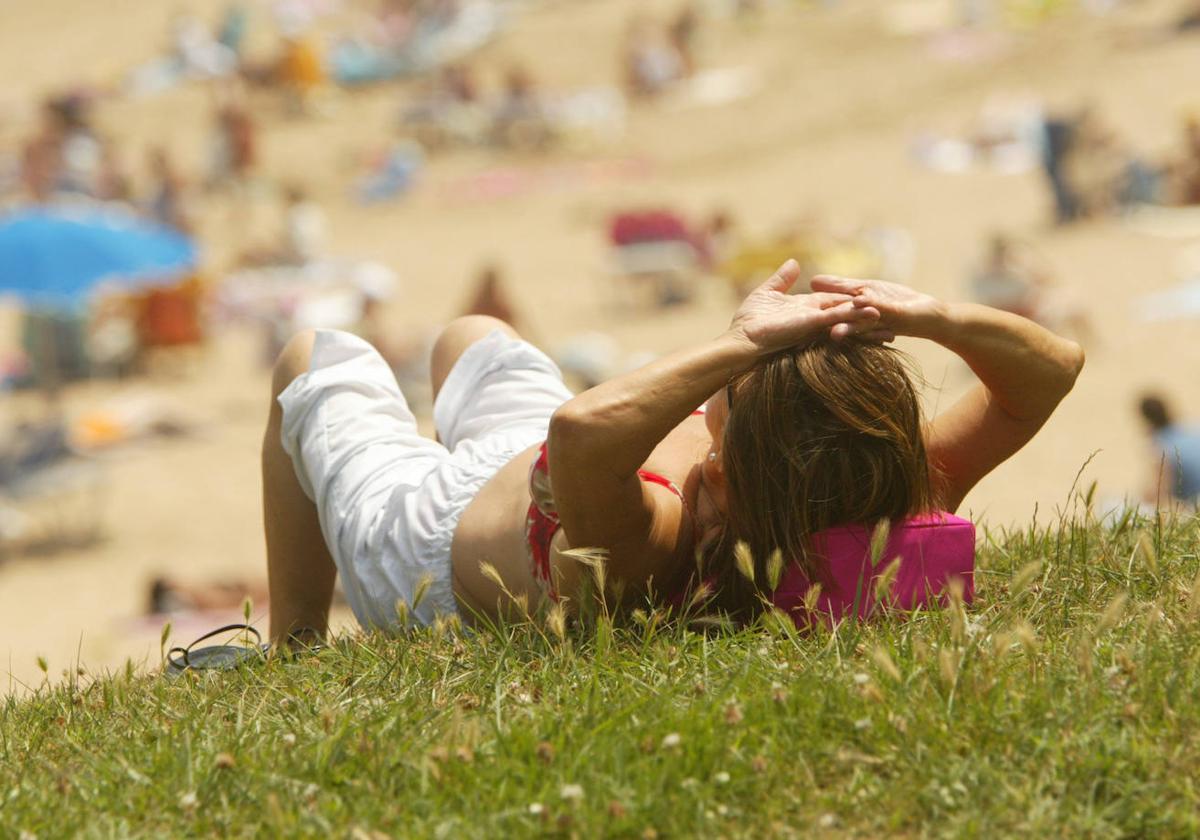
[550, 330, 757, 476]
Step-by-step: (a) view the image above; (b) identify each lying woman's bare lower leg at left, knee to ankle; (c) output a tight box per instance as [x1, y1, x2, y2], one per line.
[263, 332, 337, 644]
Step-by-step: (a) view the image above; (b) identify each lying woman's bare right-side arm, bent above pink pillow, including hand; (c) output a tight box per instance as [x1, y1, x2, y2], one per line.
[812, 277, 1084, 510]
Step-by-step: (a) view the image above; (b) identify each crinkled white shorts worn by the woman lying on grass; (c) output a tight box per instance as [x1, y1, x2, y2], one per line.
[280, 330, 571, 628]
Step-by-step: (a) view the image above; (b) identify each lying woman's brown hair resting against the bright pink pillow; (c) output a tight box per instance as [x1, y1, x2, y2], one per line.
[701, 341, 934, 620]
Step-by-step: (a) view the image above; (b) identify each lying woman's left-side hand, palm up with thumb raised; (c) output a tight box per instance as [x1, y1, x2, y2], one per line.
[730, 259, 880, 355]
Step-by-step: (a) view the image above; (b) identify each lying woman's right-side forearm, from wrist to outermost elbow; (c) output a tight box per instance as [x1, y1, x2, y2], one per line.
[919, 304, 1084, 421]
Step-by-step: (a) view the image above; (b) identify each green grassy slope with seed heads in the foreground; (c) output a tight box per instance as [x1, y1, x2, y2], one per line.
[0, 506, 1200, 838]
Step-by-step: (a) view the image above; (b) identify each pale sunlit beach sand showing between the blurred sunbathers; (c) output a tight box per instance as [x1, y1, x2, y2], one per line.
[0, 0, 1200, 683]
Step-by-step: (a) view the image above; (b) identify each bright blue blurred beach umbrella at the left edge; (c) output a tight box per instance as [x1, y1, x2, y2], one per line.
[0, 206, 196, 310]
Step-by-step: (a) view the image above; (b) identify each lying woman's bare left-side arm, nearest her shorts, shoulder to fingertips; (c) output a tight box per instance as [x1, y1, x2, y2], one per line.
[547, 260, 878, 586]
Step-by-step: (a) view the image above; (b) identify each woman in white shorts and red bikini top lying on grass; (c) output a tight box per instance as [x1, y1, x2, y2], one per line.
[263, 260, 1084, 643]
